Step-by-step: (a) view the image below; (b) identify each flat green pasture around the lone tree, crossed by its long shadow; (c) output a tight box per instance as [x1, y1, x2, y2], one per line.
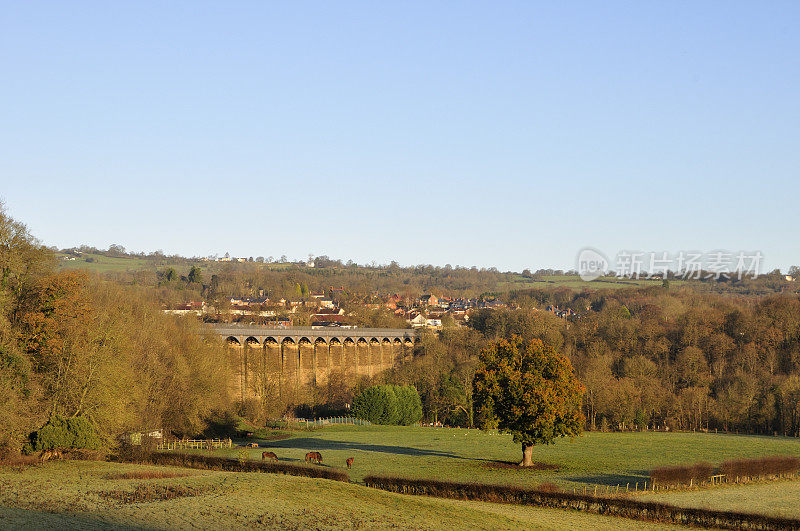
[216, 426, 800, 489]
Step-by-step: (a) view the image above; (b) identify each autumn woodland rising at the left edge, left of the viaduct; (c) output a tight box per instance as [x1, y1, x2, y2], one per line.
[0, 207, 230, 452]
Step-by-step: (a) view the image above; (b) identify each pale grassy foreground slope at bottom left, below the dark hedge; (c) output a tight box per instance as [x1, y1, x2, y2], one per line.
[0, 462, 676, 529]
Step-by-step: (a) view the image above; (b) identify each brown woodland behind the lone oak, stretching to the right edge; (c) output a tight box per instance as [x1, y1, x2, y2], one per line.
[392, 287, 800, 436]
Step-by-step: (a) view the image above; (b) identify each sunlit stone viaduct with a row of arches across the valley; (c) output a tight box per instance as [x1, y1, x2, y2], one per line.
[212, 324, 415, 400]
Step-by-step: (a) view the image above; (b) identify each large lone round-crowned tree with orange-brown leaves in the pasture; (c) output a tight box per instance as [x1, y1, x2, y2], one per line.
[473, 336, 584, 466]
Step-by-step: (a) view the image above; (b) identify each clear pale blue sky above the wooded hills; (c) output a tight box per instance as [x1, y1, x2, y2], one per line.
[0, 1, 800, 270]
